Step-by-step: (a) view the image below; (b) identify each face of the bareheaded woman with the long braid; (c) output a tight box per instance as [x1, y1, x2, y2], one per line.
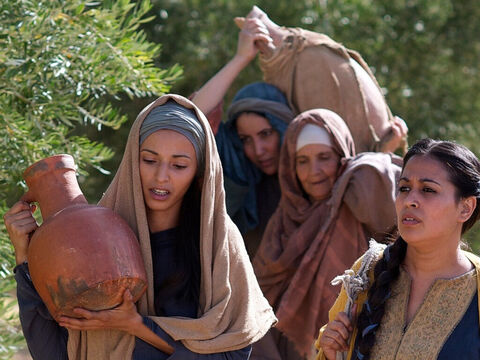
[395, 155, 471, 246]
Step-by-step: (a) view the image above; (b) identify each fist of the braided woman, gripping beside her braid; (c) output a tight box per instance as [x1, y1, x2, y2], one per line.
[320, 312, 353, 360]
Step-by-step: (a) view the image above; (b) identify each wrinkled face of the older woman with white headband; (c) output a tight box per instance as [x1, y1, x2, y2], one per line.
[295, 144, 340, 201]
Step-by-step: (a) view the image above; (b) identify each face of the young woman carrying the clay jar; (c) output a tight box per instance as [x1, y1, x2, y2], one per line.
[139, 130, 197, 216]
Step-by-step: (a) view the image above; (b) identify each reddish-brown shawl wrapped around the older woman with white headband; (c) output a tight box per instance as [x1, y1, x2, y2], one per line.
[253, 109, 401, 354]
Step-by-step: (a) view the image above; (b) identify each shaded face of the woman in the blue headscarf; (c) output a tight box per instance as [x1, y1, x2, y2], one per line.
[237, 113, 280, 175]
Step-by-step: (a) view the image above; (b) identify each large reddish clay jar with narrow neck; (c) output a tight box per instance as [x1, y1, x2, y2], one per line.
[23, 155, 147, 319]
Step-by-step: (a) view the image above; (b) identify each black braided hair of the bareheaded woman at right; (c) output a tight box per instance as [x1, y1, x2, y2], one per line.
[355, 139, 480, 360]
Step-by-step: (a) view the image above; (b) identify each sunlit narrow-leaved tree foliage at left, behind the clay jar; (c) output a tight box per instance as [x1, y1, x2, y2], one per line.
[0, 0, 181, 358]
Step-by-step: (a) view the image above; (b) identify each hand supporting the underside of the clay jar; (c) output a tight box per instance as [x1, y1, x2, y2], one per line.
[58, 289, 143, 335]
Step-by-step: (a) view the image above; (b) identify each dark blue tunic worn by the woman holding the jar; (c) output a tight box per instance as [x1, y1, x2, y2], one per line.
[15, 229, 251, 360]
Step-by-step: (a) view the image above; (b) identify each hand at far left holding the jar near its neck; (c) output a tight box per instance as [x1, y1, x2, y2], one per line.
[3, 200, 38, 265]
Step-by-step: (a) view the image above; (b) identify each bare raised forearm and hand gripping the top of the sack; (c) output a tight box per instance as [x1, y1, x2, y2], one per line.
[192, 19, 272, 114]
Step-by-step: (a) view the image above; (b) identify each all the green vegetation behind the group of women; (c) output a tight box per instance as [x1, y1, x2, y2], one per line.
[0, 0, 480, 359]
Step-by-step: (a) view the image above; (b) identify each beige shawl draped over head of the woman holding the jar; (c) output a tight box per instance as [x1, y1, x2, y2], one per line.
[68, 95, 276, 360]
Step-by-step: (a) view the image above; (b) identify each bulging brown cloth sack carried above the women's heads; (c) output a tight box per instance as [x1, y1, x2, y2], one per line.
[260, 28, 393, 153]
